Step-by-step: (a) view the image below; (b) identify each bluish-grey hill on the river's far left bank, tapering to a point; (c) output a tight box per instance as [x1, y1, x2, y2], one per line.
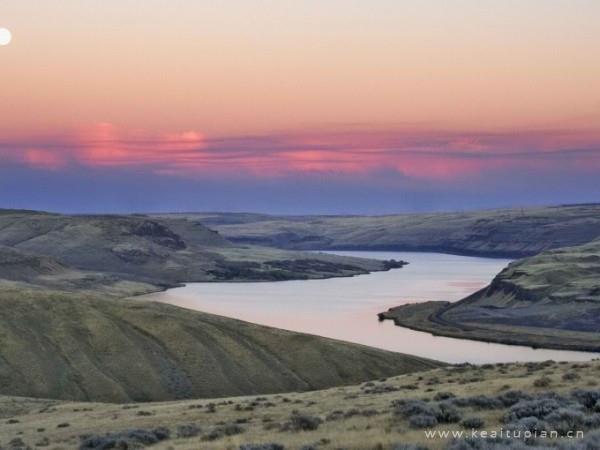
[0, 210, 398, 286]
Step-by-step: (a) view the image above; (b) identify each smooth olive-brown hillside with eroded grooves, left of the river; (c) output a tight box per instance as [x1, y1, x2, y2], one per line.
[0, 286, 439, 402]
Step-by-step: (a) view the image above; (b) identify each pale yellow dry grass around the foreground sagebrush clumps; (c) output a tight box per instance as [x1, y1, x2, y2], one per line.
[0, 362, 600, 450]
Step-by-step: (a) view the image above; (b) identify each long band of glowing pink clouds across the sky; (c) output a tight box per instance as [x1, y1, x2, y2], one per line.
[0, 123, 600, 183]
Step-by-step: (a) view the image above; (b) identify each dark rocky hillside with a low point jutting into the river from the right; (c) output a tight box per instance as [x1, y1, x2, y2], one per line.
[381, 240, 600, 351]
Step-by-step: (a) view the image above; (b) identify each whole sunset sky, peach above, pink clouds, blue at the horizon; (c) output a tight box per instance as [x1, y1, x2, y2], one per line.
[0, 0, 600, 214]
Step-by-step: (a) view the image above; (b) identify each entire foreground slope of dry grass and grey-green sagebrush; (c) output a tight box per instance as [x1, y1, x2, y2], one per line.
[0, 361, 600, 450]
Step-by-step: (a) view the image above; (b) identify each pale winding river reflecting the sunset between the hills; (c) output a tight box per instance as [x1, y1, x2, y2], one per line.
[145, 252, 599, 363]
